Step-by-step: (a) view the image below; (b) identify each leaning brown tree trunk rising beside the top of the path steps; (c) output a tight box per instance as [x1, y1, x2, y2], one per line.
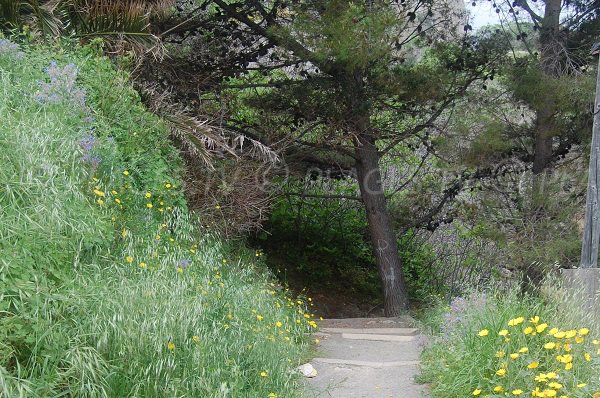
[356, 123, 409, 316]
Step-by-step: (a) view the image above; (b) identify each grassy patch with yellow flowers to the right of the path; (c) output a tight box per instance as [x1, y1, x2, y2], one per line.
[420, 283, 600, 398]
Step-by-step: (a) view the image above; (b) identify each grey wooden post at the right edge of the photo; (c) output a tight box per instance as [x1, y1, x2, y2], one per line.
[580, 48, 600, 268]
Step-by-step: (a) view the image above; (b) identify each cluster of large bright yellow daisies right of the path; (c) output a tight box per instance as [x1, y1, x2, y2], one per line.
[471, 316, 600, 398]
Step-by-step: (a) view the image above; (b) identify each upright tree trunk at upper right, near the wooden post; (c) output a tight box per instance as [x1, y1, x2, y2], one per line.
[533, 0, 563, 175]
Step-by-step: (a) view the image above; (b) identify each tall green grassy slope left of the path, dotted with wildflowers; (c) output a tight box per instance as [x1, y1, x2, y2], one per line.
[0, 40, 315, 398]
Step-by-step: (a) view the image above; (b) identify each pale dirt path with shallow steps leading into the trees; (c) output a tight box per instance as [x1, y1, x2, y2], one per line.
[307, 317, 428, 398]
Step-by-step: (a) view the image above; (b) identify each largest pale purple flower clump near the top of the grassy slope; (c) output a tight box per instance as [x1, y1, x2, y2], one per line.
[35, 61, 89, 112]
